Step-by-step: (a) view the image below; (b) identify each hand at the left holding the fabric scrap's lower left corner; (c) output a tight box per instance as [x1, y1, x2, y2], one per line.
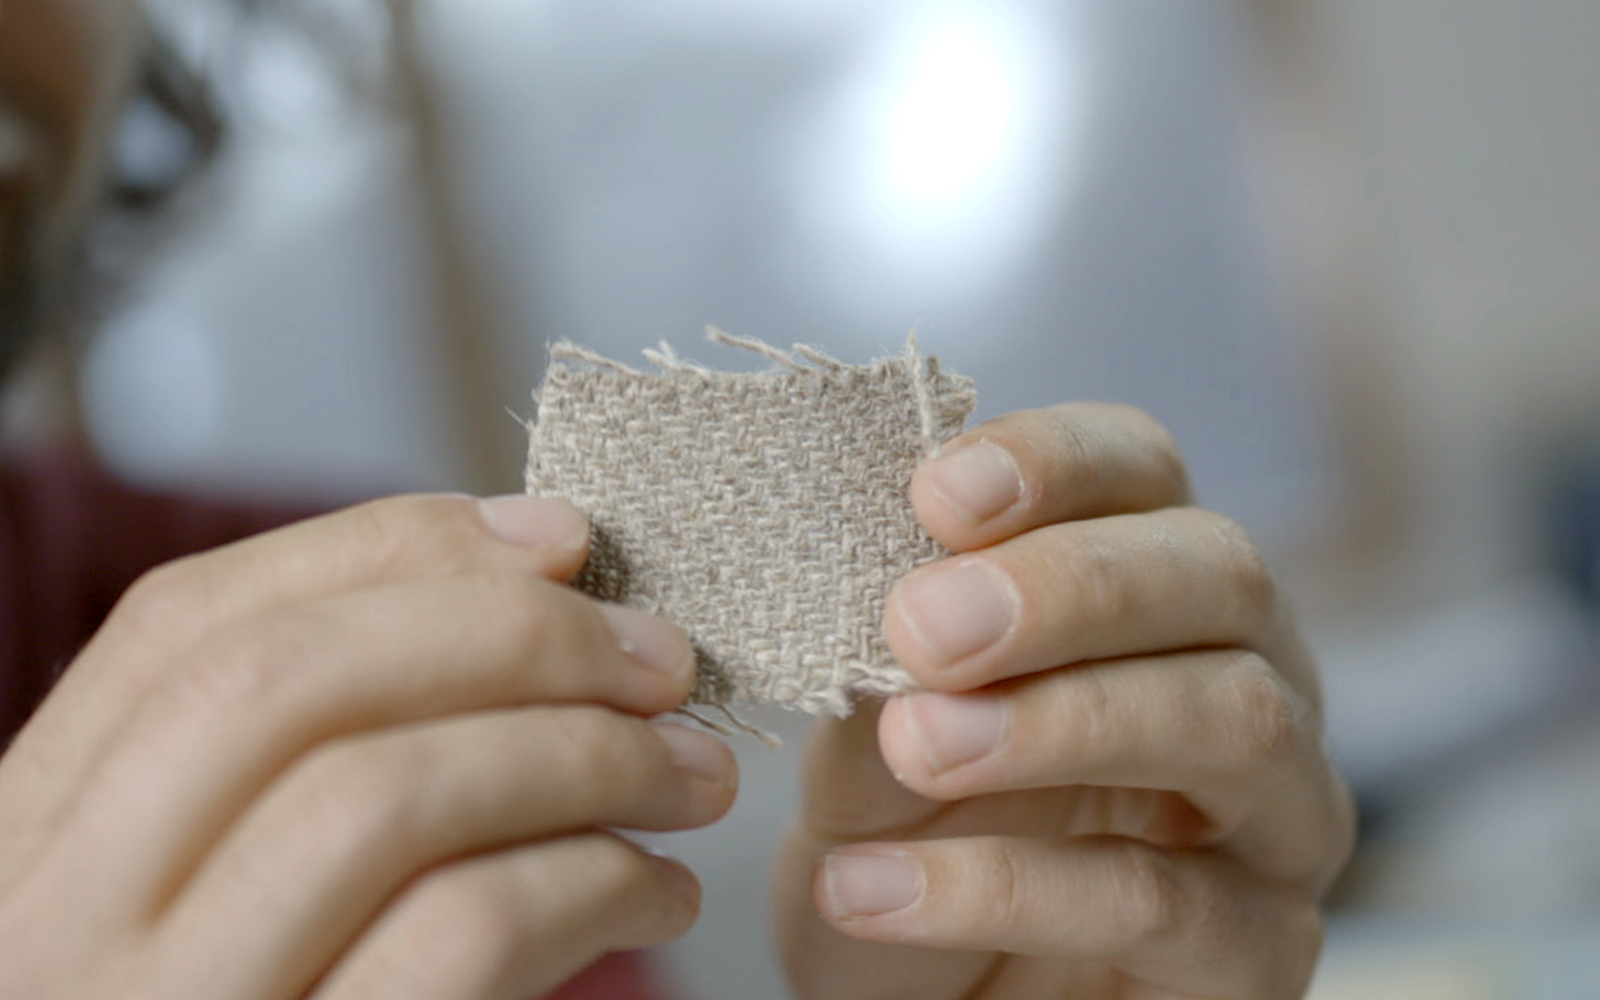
[0, 496, 736, 1000]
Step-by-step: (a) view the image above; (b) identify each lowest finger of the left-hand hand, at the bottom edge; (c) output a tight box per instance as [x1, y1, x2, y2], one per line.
[312, 834, 701, 1000]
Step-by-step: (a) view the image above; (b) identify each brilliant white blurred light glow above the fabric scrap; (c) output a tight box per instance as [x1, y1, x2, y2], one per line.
[795, 2, 1086, 308]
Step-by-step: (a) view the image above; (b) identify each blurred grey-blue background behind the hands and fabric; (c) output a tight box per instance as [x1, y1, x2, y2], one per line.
[6, 0, 1600, 1000]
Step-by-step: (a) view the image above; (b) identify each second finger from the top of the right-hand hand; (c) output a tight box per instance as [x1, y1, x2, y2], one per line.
[885, 507, 1280, 691]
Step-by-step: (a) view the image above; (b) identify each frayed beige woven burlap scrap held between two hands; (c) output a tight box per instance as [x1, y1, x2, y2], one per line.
[528, 331, 976, 715]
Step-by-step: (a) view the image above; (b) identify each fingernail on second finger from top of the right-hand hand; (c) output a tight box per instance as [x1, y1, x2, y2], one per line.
[893, 558, 1021, 666]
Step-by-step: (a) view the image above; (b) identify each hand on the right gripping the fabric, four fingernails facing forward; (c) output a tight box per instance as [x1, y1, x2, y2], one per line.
[776, 405, 1352, 1000]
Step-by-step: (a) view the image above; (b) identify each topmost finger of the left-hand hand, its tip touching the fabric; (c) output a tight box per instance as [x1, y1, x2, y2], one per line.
[0, 496, 589, 878]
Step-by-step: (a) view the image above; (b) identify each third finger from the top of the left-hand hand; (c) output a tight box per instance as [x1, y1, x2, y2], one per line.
[144, 707, 736, 997]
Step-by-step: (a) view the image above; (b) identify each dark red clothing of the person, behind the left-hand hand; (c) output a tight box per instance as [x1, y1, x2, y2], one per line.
[0, 458, 659, 1000]
